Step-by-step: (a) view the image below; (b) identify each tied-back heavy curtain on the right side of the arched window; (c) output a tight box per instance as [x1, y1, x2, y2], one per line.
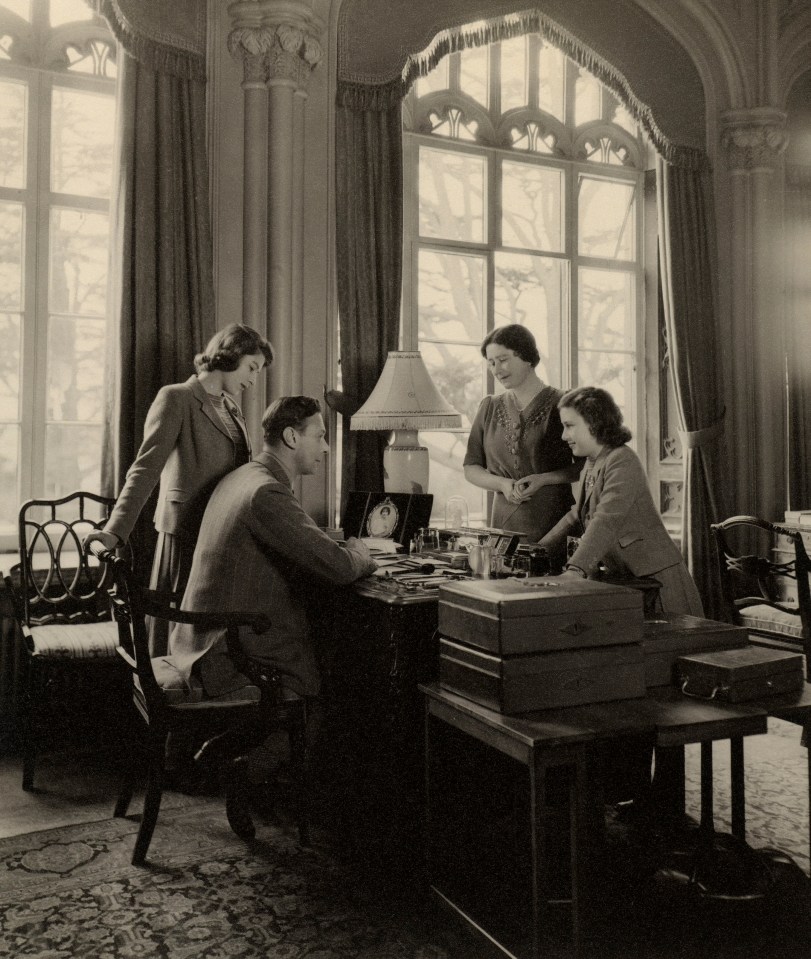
[656, 157, 727, 619]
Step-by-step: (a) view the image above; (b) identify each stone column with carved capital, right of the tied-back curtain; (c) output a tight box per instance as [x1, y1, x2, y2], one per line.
[721, 107, 788, 520]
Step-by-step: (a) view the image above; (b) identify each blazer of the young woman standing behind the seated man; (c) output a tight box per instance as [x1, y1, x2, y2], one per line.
[105, 376, 250, 541]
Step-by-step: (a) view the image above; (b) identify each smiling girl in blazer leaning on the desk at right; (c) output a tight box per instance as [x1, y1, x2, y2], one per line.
[541, 386, 704, 616]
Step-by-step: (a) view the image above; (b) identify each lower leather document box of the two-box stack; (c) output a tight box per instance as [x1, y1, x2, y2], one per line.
[439, 637, 645, 714]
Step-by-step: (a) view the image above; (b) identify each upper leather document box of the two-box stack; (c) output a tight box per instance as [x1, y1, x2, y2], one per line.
[437, 576, 643, 656]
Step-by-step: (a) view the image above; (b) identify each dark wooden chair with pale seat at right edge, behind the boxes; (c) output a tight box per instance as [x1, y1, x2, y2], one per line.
[711, 516, 811, 678]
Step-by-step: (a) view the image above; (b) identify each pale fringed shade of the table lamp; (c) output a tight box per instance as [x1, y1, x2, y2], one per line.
[350, 350, 462, 430]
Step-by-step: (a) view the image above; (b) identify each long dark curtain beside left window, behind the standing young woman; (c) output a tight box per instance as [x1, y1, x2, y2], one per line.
[94, 0, 215, 571]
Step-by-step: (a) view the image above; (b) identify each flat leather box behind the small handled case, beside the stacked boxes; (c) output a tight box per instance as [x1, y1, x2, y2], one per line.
[642, 614, 749, 686]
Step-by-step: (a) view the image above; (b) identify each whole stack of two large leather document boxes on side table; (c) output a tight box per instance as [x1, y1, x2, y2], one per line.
[438, 577, 645, 714]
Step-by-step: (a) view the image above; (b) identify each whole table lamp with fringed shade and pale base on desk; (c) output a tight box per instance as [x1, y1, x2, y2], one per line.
[350, 350, 462, 493]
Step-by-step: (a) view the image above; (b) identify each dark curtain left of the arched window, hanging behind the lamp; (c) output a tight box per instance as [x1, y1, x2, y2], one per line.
[335, 97, 403, 500]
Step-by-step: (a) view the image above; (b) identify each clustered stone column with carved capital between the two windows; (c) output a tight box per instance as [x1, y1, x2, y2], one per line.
[228, 0, 323, 437]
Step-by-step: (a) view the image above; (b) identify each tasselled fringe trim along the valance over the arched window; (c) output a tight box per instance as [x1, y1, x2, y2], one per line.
[337, 9, 709, 170]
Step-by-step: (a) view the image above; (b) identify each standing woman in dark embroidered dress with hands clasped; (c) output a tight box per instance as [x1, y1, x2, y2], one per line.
[464, 323, 581, 556]
